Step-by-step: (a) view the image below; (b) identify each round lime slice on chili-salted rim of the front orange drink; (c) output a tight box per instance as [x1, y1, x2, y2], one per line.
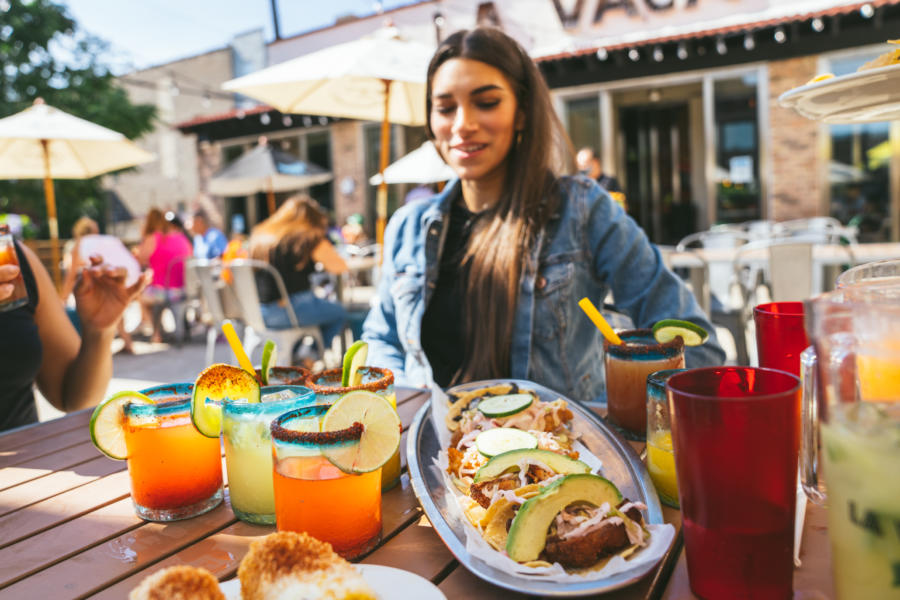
[322, 390, 401, 473]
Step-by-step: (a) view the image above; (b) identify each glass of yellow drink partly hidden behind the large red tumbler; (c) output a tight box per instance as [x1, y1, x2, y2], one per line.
[647, 369, 684, 508]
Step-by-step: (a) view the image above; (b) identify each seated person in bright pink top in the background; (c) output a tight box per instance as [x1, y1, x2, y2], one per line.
[137, 208, 193, 342]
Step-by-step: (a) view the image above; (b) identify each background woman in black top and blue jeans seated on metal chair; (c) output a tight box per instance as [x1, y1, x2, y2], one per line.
[250, 195, 347, 354]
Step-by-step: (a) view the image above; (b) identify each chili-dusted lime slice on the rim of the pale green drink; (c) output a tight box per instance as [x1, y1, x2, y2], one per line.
[191, 364, 260, 437]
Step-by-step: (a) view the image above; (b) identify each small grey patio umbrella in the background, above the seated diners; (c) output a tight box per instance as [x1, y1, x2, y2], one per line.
[209, 138, 332, 214]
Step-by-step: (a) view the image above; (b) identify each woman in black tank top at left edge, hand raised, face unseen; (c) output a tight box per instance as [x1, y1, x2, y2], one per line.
[0, 238, 148, 431]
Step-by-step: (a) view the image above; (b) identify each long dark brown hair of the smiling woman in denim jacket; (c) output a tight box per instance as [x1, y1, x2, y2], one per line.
[425, 27, 572, 383]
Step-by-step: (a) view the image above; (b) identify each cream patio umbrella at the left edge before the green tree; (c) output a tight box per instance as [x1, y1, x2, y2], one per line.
[0, 98, 155, 287]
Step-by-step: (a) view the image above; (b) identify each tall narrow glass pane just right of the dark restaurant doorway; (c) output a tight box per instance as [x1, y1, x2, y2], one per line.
[713, 73, 762, 223]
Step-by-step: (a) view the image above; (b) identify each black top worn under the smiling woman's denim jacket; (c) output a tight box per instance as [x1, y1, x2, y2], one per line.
[422, 198, 478, 387]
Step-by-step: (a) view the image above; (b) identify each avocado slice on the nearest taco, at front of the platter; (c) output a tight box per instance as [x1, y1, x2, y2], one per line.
[506, 473, 622, 562]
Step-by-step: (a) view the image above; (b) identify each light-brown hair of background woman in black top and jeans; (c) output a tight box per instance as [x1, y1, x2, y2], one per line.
[250, 194, 328, 269]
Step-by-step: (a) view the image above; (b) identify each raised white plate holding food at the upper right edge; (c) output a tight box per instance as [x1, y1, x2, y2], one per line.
[778, 64, 900, 123]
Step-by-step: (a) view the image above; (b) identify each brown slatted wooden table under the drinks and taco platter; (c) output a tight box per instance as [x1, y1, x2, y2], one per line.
[0, 389, 833, 600]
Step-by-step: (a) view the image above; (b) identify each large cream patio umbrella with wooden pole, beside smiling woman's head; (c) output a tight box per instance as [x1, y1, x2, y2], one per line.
[222, 27, 434, 244]
